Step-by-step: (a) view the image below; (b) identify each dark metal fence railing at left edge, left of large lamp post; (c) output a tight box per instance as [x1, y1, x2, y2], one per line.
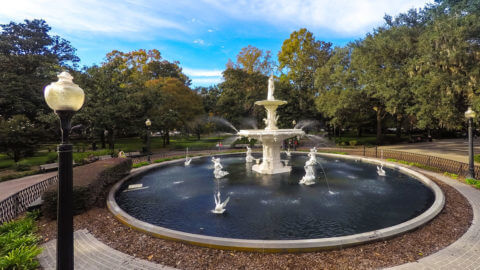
[0, 175, 58, 224]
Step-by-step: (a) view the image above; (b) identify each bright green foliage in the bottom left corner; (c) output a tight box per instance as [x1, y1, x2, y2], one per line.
[0, 213, 42, 270]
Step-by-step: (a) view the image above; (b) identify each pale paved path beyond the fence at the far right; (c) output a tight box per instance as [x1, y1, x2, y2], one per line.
[379, 139, 480, 165]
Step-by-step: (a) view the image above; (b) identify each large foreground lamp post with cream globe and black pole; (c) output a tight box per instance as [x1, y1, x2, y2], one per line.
[44, 72, 85, 270]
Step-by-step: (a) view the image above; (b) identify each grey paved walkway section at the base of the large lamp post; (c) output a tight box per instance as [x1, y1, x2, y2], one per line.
[38, 230, 175, 270]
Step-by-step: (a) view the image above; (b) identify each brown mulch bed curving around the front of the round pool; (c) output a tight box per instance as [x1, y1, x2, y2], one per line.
[39, 176, 473, 269]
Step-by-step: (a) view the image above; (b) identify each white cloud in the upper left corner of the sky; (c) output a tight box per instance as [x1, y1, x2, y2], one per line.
[0, 0, 187, 35]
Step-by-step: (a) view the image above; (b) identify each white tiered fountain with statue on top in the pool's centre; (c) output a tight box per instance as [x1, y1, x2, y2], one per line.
[237, 75, 305, 174]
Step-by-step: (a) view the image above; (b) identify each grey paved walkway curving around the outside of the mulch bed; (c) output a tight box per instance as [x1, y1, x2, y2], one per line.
[39, 169, 480, 270]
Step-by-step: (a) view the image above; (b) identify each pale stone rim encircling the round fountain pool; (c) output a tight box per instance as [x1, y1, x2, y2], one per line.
[107, 152, 445, 252]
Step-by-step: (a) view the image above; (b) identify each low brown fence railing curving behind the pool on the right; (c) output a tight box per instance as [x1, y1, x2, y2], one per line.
[319, 147, 480, 177]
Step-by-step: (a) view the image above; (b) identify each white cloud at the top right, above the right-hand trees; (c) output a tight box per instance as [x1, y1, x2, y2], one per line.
[203, 0, 433, 35]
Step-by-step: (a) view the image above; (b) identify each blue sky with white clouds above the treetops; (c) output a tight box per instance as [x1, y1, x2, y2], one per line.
[0, 0, 433, 87]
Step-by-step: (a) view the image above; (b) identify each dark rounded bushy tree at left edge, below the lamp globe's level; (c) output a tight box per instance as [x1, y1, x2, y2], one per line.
[0, 115, 39, 162]
